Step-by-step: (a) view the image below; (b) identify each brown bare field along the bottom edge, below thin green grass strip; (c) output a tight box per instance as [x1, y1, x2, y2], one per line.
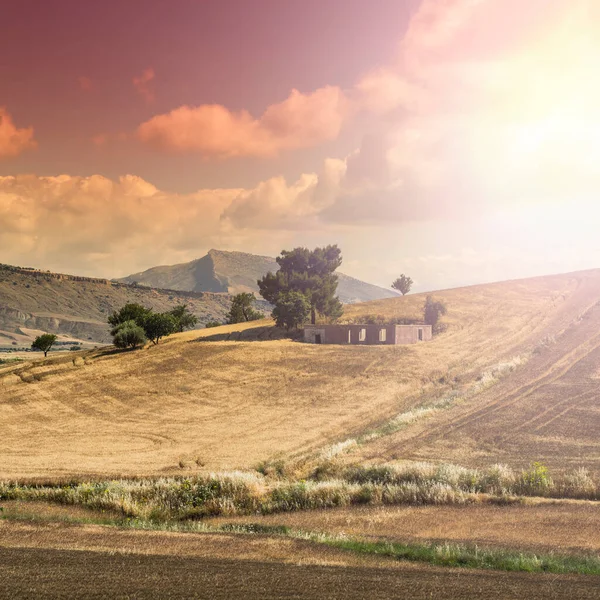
[0, 521, 600, 600]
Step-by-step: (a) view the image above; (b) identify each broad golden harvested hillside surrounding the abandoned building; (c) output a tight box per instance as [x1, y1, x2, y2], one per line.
[0, 271, 600, 478]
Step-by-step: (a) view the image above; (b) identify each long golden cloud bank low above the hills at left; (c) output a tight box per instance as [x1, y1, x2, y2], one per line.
[0, 175, 240, 275]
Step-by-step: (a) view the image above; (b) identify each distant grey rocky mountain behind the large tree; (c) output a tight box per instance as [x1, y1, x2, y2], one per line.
[115, 250, 396, 304]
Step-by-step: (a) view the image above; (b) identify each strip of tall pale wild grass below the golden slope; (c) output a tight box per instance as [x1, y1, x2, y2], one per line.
[0, 463, 600, 521]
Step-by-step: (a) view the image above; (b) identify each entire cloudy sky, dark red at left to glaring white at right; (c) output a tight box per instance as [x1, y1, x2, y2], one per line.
[0, 0, 600, 290]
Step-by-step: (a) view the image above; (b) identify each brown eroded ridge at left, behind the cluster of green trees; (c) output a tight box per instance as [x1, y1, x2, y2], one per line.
[0, 265, 234, 347]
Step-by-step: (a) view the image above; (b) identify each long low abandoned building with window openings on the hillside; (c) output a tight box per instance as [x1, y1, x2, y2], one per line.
[304, 325, 432, 345]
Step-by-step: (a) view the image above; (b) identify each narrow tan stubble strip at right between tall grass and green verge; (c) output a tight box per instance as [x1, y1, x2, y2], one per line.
[206, 501, 600, 555]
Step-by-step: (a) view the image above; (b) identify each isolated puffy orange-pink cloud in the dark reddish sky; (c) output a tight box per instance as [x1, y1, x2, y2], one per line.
[137, 86, 348, 158]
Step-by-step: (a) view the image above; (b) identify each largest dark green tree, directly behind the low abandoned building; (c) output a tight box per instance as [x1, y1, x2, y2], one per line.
[258, 245, 343, 324]
